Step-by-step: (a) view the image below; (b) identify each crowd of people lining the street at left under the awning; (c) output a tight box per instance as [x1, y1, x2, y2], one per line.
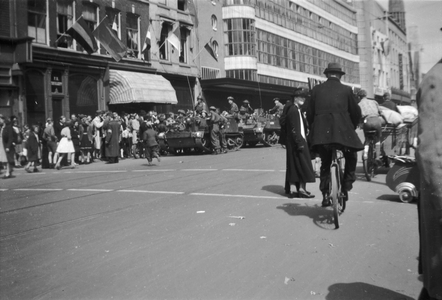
[0, 97, 264, 178]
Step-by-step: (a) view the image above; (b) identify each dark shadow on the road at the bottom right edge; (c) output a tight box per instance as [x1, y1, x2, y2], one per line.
[325, 282, 413, 300]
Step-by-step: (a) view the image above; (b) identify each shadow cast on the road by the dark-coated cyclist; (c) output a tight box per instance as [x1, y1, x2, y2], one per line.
[276, 203, 335, 230]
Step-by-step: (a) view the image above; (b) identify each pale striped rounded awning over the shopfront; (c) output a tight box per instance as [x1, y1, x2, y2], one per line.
[109, 70, 178, 104]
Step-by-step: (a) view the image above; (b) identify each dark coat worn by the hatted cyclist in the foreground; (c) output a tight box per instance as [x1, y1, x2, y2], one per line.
[307, 77, 364, 151]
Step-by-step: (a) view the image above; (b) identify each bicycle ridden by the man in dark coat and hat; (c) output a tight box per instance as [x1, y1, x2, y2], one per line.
[329, 145, 345, 229]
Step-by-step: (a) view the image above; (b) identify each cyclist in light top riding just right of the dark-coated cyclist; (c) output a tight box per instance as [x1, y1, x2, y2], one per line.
[357, 90, 387, 159]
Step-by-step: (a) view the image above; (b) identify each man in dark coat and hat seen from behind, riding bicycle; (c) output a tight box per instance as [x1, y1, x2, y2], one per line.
[307, 63, 364, 207]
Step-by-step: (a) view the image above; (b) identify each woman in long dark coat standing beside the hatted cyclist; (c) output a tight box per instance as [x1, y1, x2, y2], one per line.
[285, 89, 315, 198]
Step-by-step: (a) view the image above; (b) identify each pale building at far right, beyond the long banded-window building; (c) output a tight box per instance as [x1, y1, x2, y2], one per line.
[354, 0, 411, 104]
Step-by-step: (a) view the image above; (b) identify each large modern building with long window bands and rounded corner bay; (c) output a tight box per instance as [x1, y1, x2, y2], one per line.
[196, 0, 359, 109]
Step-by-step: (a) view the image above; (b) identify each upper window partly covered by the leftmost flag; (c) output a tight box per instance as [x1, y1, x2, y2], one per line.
[57, 0, 74, 49]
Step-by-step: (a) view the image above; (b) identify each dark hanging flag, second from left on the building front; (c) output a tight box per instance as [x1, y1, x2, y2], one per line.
[92, 16, 127, 61]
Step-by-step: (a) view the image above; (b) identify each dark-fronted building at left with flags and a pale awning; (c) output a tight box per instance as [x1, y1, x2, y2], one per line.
[0, 0, 198, 123]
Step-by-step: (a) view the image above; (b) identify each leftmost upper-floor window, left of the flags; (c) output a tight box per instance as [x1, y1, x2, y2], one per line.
[28, 0, 47, 44]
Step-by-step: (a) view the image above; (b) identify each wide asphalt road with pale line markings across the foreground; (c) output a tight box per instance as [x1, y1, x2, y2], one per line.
[0, 147, 422, 300]
